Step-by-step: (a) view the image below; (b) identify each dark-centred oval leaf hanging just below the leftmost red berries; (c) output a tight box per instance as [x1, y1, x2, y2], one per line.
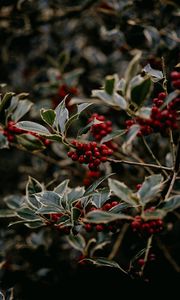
[16, 133, 46, 151]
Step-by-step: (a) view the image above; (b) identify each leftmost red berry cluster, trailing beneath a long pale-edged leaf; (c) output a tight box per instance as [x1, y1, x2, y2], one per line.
[2, 121, 51, 146]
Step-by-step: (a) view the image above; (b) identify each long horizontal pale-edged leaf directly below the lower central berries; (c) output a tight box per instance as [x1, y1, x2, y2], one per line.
[83, 209, 133, 224]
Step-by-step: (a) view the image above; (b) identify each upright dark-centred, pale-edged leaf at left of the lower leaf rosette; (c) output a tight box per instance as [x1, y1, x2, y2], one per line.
[26, 176, 44, 209]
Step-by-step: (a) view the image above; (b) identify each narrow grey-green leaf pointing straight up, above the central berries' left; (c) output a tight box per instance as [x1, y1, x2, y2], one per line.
[55, 96, 69, 133]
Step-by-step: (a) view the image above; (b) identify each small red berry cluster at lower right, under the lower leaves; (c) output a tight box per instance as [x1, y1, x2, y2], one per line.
[131, 216, 163, 235]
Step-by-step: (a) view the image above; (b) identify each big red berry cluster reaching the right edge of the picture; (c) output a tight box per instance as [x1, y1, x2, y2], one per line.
[126, 92, 180, 136]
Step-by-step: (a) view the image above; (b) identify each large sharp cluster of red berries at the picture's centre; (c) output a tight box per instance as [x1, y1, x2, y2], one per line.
[68, 140, 113, 171]
